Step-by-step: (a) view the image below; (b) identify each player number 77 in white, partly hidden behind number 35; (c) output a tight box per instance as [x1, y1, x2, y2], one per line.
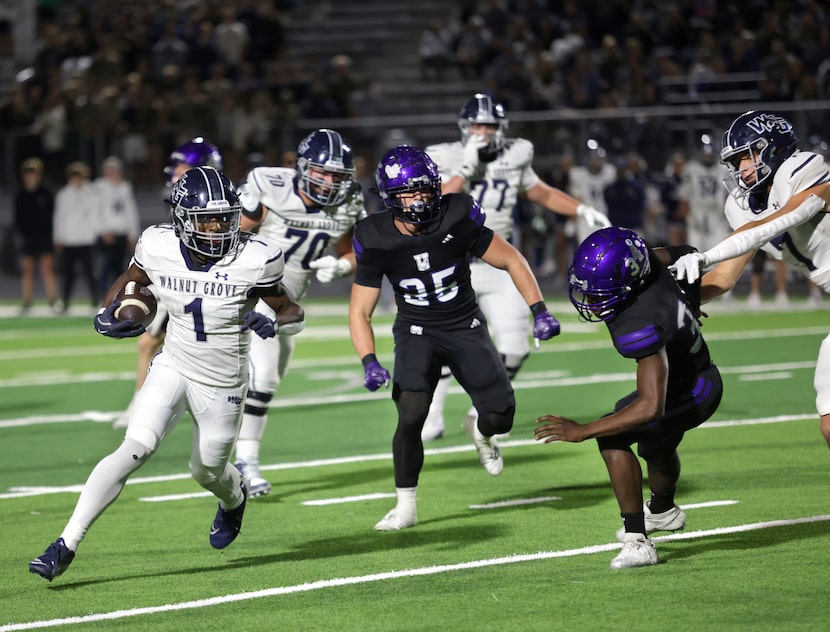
[423, 94, 609, 441]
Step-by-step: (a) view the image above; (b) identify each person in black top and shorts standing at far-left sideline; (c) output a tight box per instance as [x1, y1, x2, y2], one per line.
[14, 158, 63, 314]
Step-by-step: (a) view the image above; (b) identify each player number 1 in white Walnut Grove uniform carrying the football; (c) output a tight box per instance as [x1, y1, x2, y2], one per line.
[29, 167, 304, 581]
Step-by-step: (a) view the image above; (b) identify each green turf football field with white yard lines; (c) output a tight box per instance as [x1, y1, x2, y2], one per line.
[0, 301, 830, 632]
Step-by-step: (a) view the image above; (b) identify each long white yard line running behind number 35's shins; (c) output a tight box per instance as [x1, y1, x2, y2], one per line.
[0, 413, 817, 500]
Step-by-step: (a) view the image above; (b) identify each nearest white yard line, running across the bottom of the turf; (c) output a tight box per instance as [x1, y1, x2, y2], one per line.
[0, 515, 830, 632]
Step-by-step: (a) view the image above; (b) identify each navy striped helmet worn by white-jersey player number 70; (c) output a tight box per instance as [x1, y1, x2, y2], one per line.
[297, 129, 354, 206]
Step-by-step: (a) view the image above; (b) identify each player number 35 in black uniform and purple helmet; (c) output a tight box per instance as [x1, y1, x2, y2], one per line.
[349, 145, 559, 531]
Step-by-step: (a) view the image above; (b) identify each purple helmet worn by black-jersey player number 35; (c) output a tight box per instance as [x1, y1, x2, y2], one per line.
[375, 145, 441, 224]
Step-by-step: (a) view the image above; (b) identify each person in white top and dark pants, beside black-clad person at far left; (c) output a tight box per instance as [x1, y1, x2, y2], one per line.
[53, 162, 101, 309]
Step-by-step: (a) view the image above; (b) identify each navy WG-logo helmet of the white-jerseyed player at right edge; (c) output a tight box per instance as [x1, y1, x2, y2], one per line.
[720, 110, 798, 193]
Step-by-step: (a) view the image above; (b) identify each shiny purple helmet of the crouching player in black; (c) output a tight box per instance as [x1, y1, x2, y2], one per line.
[568, 226, 651, 322]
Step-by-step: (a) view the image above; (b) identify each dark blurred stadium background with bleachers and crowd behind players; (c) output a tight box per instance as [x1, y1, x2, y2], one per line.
[0, 0, 830, 306]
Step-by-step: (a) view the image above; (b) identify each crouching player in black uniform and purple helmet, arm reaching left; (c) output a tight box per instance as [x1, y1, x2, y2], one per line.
[533, 226, 723, 569]
